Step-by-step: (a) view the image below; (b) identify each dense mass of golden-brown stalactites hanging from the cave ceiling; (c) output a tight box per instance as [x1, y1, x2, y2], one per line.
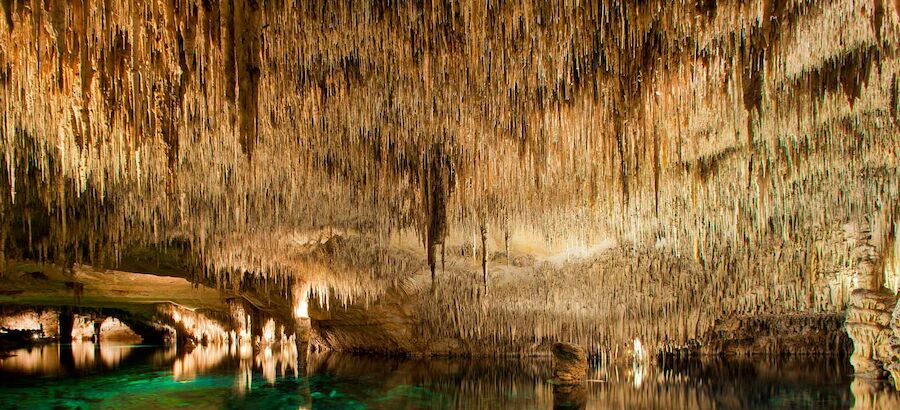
[0, 0, 900, 350]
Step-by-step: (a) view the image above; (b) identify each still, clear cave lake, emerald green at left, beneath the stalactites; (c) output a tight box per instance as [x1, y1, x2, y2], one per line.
[0, 343, 886, 409]
